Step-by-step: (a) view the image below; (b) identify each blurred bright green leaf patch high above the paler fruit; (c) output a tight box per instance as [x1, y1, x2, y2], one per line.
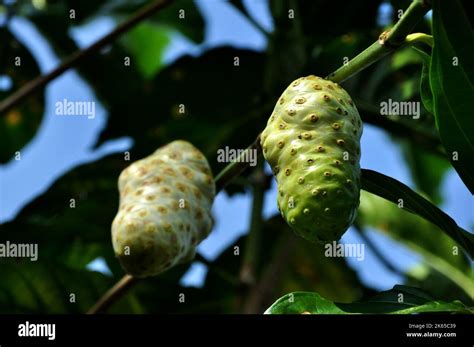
[121, 22, 170, 79]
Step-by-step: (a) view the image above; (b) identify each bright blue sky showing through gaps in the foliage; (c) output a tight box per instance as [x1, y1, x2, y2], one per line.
[0, 0, 474, 290]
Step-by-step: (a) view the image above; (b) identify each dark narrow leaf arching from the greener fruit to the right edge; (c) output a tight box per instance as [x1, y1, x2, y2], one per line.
[361, 169, 474, 259]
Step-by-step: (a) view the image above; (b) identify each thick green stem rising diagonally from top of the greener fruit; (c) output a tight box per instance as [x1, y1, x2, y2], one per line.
[326, 0, 430, 83]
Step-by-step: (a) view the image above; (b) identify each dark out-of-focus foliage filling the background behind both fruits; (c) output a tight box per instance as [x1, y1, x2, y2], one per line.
[0, 0, 474, 313]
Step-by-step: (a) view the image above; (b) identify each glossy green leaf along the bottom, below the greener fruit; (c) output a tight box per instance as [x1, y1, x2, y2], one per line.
[265, 286, 470, 314]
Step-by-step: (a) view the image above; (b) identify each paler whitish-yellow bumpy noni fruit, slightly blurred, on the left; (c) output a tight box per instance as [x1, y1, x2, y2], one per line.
[112, 141, 215, 278]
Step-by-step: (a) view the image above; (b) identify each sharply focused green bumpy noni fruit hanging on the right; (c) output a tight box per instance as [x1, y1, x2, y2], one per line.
[261, 76, 362, 243]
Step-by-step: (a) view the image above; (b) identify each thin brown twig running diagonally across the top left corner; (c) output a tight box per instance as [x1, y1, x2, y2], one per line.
[0, 0, 172, 114]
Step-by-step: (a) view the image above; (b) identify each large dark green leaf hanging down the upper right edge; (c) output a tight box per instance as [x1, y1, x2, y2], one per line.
[430, 0, 474, 194]
